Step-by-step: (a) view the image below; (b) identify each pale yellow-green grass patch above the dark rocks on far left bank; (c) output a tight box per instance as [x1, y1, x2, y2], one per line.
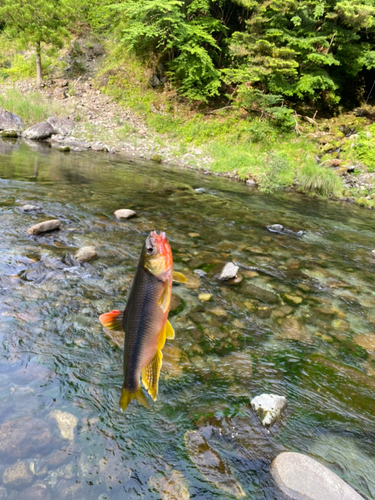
[0, 88, 67, 127]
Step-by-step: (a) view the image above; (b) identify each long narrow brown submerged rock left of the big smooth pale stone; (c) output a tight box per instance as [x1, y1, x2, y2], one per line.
[185, 431, 246, 498]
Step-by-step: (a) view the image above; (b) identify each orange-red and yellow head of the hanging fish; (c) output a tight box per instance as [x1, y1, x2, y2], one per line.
[142, 231, 173, 279]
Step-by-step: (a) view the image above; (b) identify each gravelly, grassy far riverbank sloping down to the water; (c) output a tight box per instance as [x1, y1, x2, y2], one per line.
[0, 71, 375, 208]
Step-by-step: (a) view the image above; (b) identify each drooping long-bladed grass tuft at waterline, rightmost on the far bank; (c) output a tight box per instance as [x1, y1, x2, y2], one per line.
[298, 163, 343, 197]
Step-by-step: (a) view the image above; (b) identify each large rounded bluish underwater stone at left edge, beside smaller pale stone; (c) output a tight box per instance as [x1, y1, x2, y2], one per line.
[0, 417, 53, 462]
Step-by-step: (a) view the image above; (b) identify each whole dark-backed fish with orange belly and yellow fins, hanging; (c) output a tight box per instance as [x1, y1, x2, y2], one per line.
[99, 231, 186, 412]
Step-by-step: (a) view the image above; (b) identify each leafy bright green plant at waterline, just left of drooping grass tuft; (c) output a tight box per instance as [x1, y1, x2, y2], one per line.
[258, 151, 294, 194]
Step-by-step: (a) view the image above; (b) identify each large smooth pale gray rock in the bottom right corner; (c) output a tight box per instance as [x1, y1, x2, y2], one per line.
[271, 452, 363, 500]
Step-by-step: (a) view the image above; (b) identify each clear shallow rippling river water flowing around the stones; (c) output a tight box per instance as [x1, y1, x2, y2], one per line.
[0, 139, 375, 500]
